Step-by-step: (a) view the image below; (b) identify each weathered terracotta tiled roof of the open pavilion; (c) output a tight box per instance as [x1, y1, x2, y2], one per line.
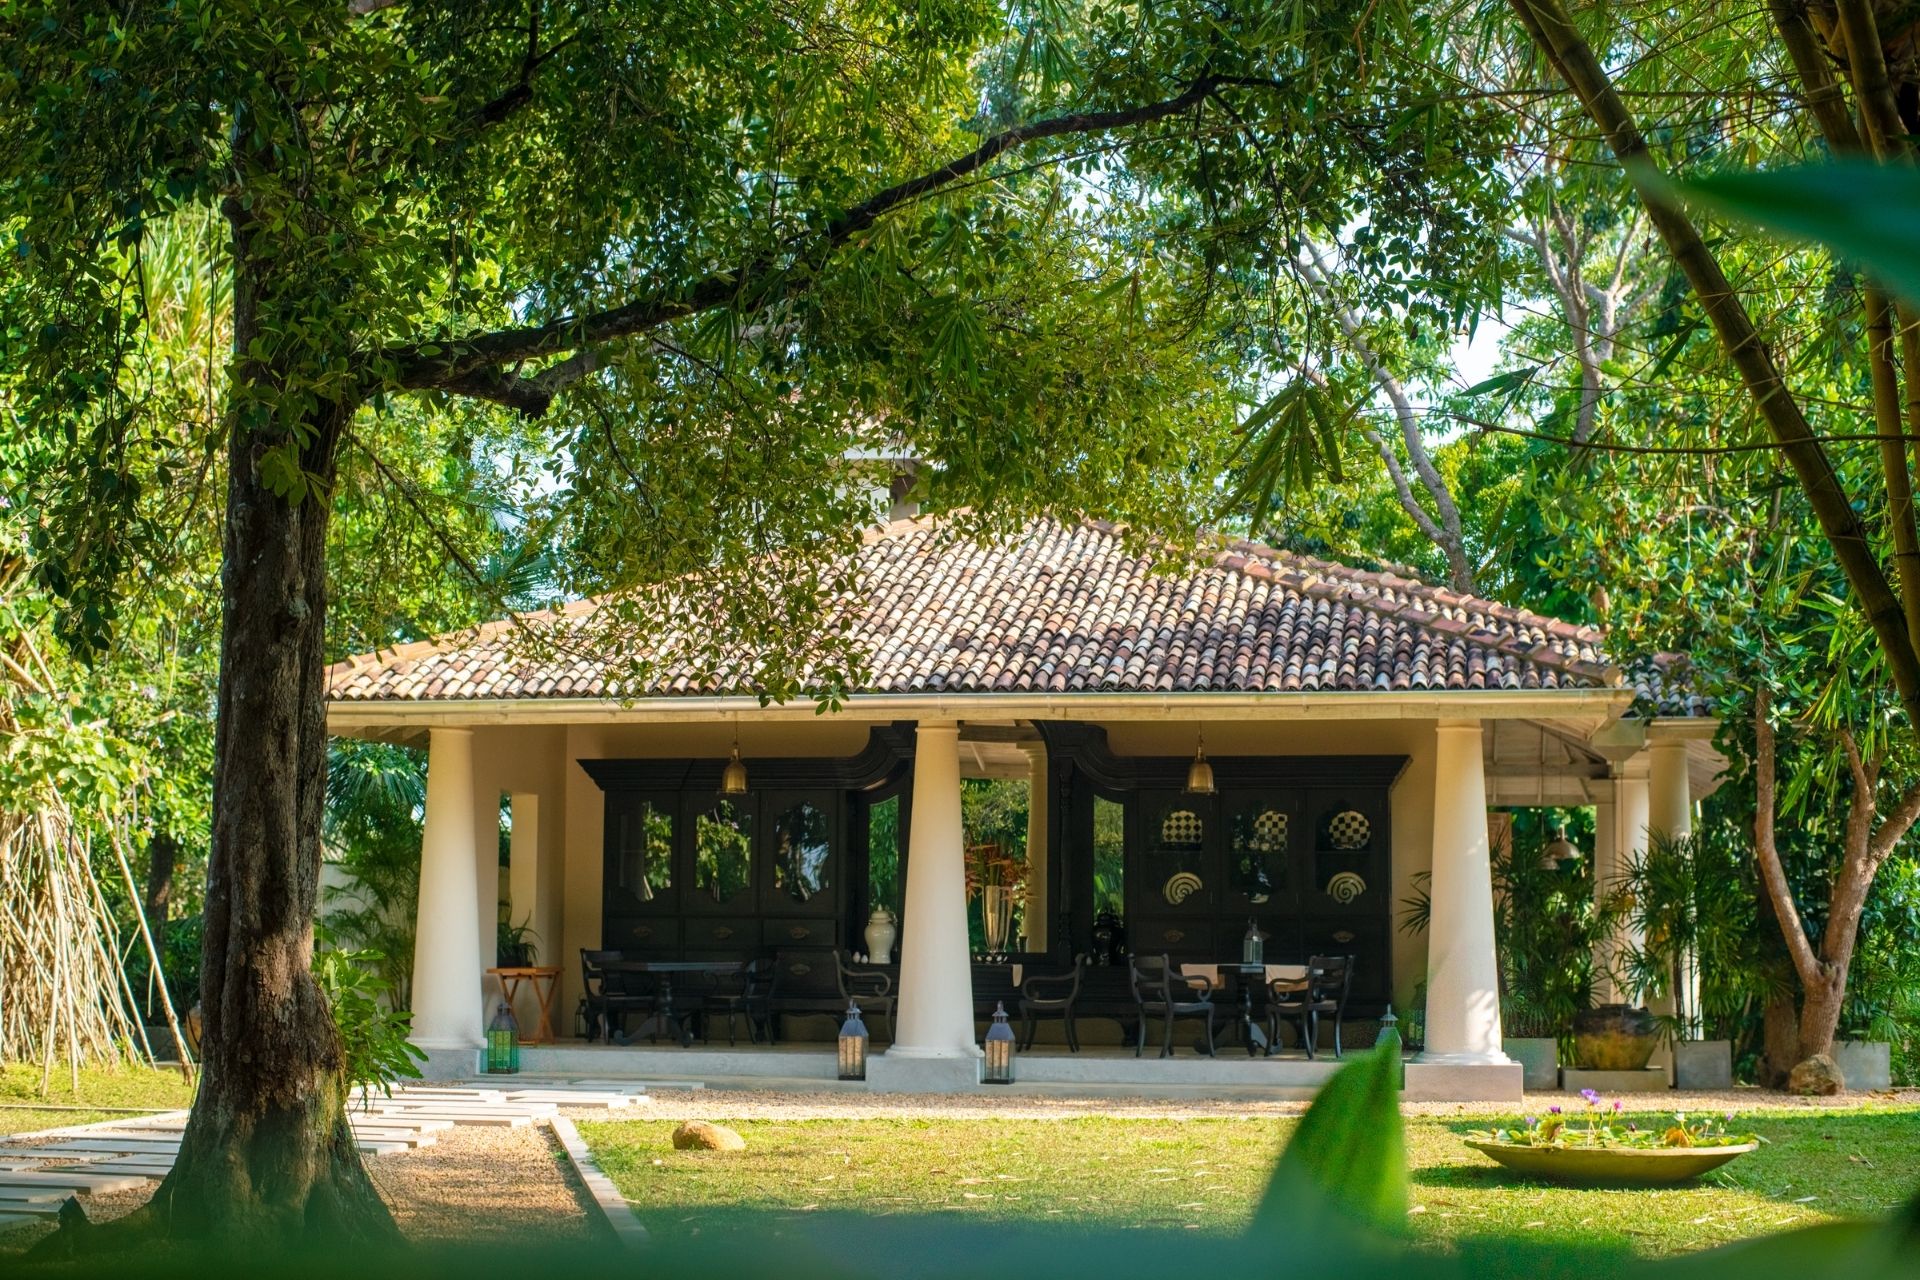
[328, 520, 1703, 714]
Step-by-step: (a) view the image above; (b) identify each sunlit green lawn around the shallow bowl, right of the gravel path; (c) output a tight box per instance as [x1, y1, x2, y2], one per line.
[580, 1109, 1920, 1255]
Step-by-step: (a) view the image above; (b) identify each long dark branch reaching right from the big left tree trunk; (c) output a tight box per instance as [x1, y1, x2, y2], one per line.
[386, 77, 1217, 415]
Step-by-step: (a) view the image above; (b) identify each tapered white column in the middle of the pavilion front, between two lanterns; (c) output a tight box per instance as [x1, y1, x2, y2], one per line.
[887, 720, 979, 1057]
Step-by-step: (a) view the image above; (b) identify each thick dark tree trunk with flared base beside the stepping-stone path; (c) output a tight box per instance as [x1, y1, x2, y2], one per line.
[54, 228, 397, 1247]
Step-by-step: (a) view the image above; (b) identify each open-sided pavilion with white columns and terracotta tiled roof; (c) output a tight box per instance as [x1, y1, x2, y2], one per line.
[328, 520, 1724, 1100]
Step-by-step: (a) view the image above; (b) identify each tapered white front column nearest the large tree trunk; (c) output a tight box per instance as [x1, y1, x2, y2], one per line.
[413, 729, 486, 1050]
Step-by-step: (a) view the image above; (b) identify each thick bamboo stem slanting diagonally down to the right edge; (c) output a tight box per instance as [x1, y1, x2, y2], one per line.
[1509, 0, 1920, 733]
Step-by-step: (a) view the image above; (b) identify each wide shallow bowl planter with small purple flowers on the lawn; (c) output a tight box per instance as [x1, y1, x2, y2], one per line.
[1467, 1088, 1761, 1186]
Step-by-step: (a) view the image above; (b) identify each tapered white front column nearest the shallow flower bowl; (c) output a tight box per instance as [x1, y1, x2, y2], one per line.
[1419, 720, 1509, 1067]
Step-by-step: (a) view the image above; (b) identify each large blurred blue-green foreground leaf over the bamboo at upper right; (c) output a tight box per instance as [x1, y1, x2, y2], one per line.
[1642, 159, 1920, 305]
